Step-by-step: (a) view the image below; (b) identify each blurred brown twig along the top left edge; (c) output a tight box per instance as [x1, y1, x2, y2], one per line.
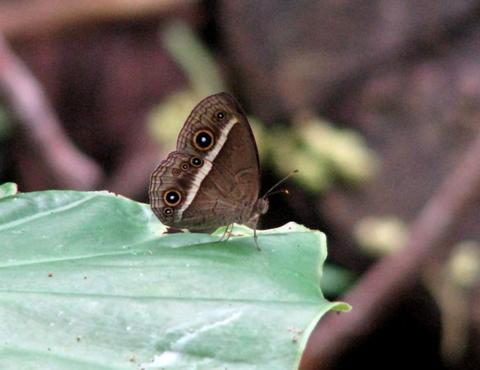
[0, 0, 194, 38]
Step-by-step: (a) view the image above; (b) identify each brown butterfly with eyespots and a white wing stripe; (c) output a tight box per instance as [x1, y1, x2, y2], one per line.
[149, 93, 268, 248]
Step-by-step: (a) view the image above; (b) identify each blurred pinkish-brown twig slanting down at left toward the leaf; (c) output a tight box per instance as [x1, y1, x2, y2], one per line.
[0, 35, 103, 189]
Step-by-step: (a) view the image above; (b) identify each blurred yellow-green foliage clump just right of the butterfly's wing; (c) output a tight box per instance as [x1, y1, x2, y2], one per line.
[260, 117, 379, 193]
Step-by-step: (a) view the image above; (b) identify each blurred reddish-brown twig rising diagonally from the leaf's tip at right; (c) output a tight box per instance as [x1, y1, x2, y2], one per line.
[301, 128, 480, 369]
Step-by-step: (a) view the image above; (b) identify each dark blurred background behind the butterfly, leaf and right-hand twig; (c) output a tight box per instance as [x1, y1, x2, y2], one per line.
[0, 0, 480, 370]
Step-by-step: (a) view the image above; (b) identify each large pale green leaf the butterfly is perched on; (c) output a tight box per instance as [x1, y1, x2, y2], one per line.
[0, 191, 349, 370]
